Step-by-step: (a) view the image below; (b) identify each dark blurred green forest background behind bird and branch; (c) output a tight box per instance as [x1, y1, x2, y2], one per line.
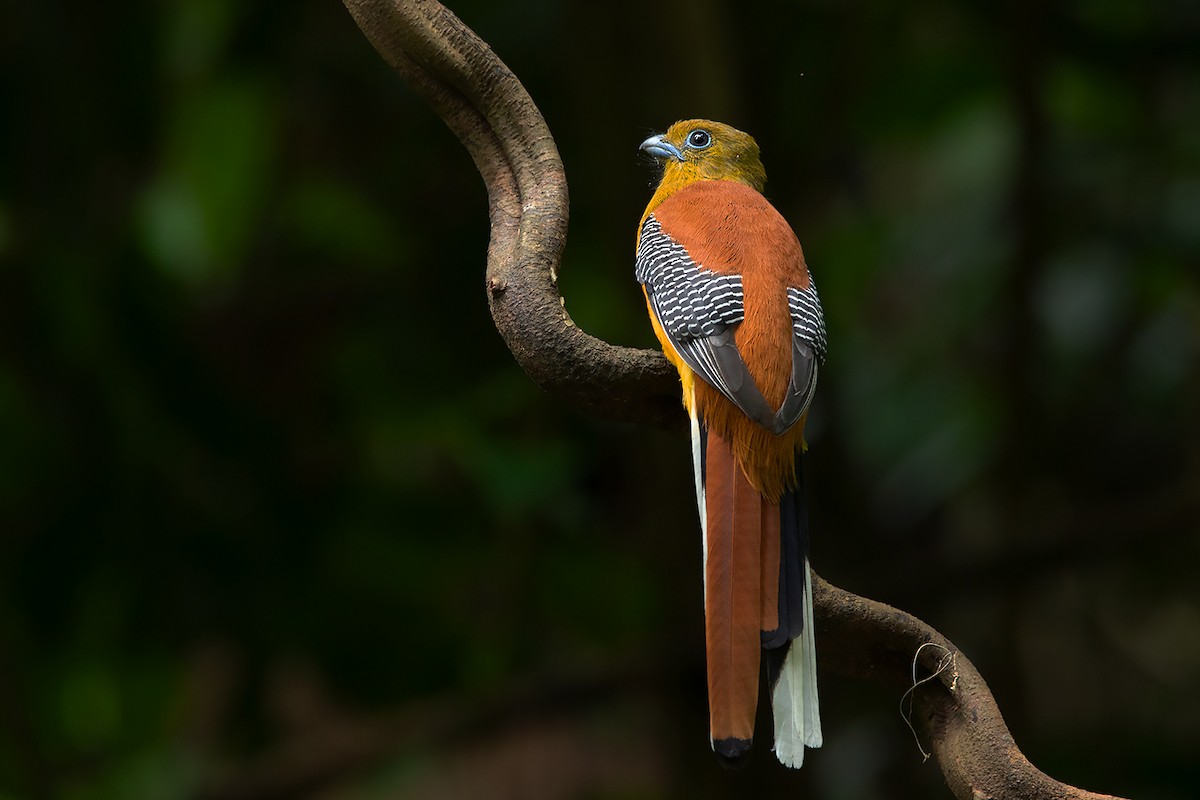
[0, 0, 1200, 800]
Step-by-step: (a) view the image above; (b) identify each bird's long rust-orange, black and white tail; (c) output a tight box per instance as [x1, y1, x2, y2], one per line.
[692, 417, 821, 766]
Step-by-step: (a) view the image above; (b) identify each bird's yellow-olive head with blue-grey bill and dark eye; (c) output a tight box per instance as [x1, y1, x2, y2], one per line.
[641, 120, 767, 192]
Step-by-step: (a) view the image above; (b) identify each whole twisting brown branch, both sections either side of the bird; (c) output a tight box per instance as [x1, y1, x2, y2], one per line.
[343, 0, 1128, 800]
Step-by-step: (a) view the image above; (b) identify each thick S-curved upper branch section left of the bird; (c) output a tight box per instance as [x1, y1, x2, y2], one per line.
[344, 0, 680, 427]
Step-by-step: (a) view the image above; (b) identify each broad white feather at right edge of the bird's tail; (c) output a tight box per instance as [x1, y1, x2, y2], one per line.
[770, 558, 822, 769]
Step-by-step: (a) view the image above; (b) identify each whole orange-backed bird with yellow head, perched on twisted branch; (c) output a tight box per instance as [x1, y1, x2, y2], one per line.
[635, 120, 827, 768]
